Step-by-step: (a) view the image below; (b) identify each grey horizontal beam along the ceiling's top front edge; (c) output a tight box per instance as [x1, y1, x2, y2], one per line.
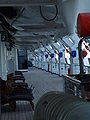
[0, 0, 59, 6]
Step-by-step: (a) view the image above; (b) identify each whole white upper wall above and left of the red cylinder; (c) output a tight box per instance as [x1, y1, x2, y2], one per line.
[61, 0, 90, 34]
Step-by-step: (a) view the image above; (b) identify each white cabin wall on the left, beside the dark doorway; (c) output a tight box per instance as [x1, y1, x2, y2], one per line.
[0, 34, 18, 80]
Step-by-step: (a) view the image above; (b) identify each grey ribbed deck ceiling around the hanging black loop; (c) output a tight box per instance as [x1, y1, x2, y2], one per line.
[13, 3, 67, 48]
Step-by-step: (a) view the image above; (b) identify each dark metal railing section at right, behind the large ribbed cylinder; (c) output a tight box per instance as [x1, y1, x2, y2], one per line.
[63, 74, 90, 101]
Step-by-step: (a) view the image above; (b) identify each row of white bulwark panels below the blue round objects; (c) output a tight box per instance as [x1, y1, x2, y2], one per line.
[33, 60, 90, 76]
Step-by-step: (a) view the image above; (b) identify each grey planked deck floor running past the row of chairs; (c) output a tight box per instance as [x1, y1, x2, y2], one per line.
[1, 68, 64, 120]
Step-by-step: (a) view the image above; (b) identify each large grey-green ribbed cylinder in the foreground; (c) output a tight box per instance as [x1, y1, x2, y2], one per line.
[34, 91, 90, 120]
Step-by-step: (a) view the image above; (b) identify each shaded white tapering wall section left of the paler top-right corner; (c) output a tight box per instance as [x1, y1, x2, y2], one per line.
[62, 0, 78, 34]
